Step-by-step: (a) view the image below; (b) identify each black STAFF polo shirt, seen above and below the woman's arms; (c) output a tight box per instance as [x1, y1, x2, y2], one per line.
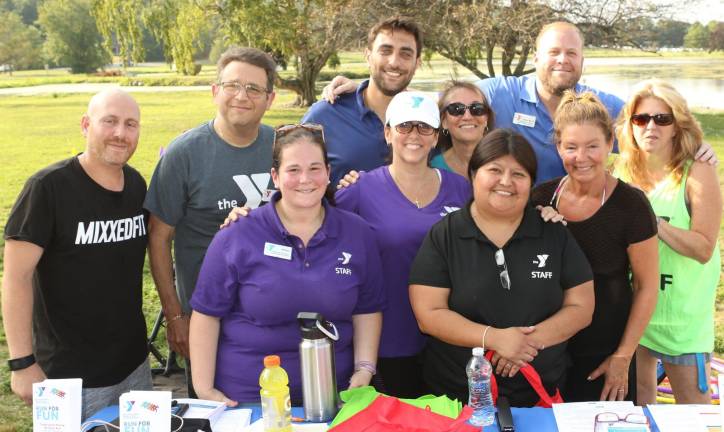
[410, 204, 593, 406]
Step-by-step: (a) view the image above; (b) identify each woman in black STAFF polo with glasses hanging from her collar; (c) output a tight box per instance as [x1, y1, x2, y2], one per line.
[410, 129, 594, 406]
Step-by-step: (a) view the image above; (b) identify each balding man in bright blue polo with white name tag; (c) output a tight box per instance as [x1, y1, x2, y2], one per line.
[477, 22, 624, 183]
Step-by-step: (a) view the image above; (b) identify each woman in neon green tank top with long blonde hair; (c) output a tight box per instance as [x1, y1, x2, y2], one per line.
[617, 80, 722, 404]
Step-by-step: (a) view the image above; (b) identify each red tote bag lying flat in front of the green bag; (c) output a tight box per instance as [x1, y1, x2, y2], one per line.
[329, 395, 480, 432]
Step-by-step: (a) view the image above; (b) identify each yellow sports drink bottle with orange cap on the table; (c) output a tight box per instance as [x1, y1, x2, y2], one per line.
[259, 356, 292, 432]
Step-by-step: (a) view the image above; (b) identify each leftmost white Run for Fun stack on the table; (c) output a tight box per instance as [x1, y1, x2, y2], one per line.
[33, 378, 83, 432]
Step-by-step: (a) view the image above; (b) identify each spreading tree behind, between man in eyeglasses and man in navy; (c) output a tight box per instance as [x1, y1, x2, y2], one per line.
[206, 0, 365, 106]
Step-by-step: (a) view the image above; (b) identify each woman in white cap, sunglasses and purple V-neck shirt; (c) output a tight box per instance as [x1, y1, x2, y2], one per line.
[336, 92, 470, 398]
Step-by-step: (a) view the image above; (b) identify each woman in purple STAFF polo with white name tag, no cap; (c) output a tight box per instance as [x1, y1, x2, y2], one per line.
[190, 125, 385, 406]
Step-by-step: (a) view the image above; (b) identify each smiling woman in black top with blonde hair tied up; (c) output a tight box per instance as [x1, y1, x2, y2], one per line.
[531, 91, 659, 402]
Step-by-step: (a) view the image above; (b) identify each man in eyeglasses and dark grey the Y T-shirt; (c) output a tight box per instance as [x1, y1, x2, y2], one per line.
[144, 48, 276, 393]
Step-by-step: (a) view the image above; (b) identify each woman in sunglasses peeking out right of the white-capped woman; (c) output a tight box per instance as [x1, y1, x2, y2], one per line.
[430, 81, 495, 177]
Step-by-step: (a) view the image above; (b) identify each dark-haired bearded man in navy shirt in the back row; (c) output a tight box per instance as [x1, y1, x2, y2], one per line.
[302, 16, 422, 184]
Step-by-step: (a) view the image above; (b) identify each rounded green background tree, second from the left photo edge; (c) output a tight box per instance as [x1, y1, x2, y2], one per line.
[38, 0, 109, 73]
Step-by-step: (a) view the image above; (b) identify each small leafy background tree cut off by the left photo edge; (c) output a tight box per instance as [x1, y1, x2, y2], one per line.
[0, 12, 42, 74]
